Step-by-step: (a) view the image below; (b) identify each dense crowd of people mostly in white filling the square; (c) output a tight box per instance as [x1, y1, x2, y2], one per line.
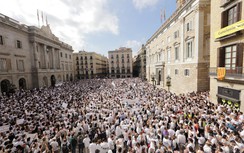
[0, 78, 244, 153]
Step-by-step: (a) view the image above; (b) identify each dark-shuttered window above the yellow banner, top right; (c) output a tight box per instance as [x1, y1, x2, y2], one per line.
[221, 3, 242, 28]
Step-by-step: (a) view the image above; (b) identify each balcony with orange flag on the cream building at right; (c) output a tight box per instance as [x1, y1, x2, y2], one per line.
[209, 67, 244, 84]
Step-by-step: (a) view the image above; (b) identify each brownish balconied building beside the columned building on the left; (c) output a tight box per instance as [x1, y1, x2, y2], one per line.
[73, 51, 108, 79]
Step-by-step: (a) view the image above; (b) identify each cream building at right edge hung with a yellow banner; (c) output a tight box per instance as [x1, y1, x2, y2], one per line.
[210, 0, 244, 112]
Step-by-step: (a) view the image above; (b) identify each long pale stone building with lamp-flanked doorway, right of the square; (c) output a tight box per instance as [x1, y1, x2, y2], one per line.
[145, 0, 210, 94]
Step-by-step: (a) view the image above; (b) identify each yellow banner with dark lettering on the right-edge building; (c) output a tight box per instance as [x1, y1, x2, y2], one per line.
[214, 20, 244, 39]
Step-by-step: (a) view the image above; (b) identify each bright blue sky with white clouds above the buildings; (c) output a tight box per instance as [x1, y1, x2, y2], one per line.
[0, 0, 176, 56]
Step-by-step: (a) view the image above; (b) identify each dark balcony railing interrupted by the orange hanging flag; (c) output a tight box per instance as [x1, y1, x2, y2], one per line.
[209, 67, 244, 79]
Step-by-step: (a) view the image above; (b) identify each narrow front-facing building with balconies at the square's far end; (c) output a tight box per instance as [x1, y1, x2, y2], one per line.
[108, 47, 133, 78]
